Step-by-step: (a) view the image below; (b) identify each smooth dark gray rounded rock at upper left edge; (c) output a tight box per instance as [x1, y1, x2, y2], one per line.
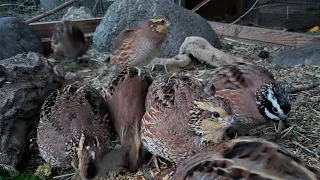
[0, 17, 43, 60]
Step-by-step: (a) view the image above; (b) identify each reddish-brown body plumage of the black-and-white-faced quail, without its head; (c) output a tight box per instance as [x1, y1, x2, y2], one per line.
[203, 63, 284, 128]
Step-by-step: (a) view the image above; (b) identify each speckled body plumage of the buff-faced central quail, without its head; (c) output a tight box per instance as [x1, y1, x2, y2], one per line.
[141, 76, 234, 163]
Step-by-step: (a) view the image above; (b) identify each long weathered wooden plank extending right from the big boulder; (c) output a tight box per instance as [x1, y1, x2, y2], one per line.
[208, 21, 320, 46]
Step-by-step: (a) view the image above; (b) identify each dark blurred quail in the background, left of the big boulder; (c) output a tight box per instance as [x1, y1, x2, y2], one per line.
[51, 21, 89, 60]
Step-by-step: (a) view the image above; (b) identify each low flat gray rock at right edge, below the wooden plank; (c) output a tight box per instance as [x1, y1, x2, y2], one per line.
[271, 42, 320, 66]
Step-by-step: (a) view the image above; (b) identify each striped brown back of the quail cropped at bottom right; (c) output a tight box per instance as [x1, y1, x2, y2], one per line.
[173, 138, 320, 180]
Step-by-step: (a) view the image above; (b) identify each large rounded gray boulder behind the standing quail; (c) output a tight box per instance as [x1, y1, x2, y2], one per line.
[93, 0, 221, 57]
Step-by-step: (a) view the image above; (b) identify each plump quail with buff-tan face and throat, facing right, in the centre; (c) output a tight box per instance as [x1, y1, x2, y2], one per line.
[141, 76, 234, 164]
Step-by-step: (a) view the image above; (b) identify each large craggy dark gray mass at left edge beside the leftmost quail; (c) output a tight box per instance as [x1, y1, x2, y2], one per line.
[0, 52, 63, 167]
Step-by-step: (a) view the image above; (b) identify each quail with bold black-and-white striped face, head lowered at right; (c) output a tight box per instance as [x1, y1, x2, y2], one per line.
[204, 63, 291, 133]
